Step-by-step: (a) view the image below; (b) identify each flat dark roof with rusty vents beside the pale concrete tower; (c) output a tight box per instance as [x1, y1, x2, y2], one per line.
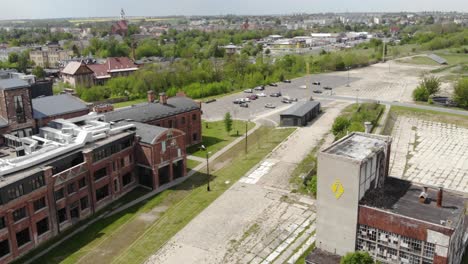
[360, 177, 466, 225]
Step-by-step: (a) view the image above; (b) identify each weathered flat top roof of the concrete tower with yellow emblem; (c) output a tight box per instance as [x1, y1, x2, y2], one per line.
[323, 133, 392, 161]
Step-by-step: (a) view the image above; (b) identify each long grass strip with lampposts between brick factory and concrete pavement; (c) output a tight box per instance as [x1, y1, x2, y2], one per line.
[28, 127, 294, 263]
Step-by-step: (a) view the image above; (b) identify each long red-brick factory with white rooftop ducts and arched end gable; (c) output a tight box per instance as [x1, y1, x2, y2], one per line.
[0, 114, 186, 263]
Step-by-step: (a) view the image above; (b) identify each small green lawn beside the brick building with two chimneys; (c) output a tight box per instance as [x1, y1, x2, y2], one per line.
[187, 120, 255, 158]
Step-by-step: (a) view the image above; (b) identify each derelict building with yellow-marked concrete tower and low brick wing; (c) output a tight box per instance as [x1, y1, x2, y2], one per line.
[316, 133, 468, 264]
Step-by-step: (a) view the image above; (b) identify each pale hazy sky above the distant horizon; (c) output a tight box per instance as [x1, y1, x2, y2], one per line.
[0, 0, 468, 20]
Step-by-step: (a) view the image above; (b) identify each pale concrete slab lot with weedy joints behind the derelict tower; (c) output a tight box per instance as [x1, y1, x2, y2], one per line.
[390, 116, 468, 192]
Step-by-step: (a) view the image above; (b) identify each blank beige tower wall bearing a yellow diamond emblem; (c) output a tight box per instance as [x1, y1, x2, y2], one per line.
[316, 152, 360, 255]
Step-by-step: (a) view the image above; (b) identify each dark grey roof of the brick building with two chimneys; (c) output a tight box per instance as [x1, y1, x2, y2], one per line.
[104, 96, 200, 123]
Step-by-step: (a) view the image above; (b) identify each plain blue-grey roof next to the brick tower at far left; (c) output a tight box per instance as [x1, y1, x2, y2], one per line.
[32, 94, 88, 119]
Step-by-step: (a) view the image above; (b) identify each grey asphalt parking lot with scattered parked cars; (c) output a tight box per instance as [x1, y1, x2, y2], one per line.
[202, 74, 358, 125]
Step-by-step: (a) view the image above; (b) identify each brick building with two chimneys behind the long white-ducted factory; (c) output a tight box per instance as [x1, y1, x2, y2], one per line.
[104, 91, 202, 146]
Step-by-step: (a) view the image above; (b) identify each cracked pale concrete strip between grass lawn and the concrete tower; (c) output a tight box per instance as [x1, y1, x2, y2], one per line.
[147, 102, 348, 264]
